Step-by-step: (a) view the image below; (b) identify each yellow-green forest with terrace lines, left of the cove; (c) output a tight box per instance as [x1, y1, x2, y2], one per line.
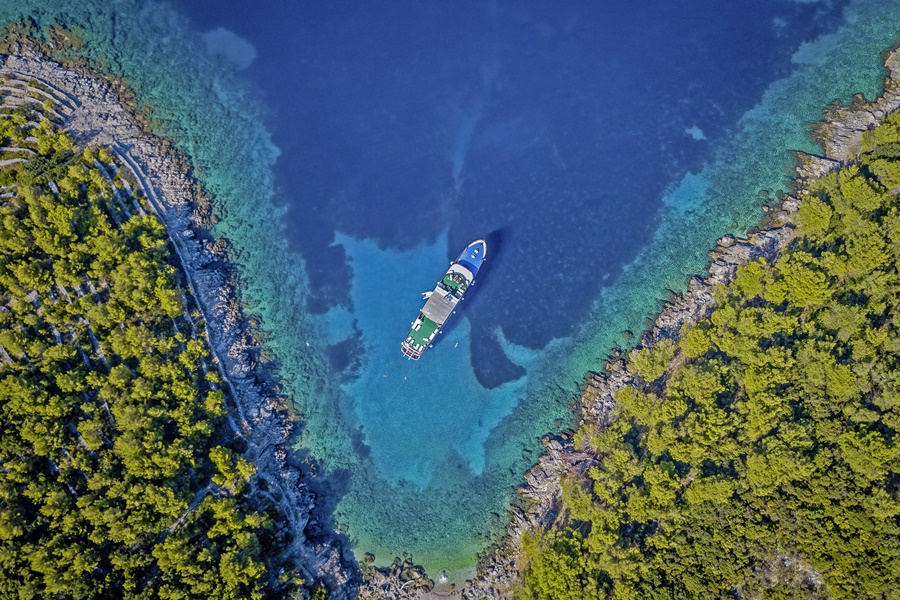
[0, 83, 299, 599]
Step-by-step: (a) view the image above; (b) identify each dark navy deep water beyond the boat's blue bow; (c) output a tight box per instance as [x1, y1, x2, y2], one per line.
[182, 0, 843, 387]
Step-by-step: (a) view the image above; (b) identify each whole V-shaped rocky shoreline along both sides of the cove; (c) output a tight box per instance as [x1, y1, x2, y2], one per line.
[7, 34, 900, 600]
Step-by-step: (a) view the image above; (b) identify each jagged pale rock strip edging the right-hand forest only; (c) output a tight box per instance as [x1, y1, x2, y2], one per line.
[414, 44, 900, 600]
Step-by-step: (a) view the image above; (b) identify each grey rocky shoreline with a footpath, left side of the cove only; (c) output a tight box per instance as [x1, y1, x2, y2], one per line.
[0, 45, 359, 598]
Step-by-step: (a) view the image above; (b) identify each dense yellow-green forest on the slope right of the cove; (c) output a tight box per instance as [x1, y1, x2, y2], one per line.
[521, 113, 900, 600]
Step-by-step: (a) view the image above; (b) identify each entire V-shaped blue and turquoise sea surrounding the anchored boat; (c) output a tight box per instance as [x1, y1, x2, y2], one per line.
[7, 0, 900, 583]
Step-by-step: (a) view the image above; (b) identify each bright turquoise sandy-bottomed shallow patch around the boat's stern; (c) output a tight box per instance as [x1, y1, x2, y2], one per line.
[327, 236, 525, 482]
